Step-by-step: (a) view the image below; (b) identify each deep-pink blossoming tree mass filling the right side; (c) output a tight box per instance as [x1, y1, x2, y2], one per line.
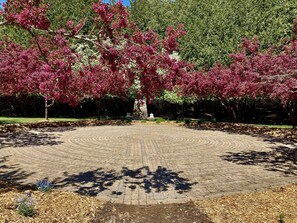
[182, 20, 297, 127]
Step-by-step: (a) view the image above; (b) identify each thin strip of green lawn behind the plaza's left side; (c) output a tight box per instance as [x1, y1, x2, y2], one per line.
[0, 117, 90, 124]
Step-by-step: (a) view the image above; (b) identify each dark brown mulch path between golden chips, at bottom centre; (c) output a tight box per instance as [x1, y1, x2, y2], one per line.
[93, 202, 212, 223]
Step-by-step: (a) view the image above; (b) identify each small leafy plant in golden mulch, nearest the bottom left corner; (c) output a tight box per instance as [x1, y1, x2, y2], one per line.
[15, 192, 35, 217]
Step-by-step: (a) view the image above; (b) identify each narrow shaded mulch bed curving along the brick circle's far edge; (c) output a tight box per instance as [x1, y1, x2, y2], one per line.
[0, 119, 297, 142]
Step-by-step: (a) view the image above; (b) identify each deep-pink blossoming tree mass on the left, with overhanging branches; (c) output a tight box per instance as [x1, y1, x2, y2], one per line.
[0, 0, 189, 118]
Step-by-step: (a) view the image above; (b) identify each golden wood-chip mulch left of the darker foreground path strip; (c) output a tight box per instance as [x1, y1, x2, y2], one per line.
[0, 180, 103, 223]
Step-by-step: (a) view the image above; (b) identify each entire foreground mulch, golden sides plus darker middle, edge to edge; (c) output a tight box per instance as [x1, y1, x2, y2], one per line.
[0, 180, 297, 223]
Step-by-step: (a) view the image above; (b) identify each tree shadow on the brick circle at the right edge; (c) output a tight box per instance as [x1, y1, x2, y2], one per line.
[221, 146, 297, 176]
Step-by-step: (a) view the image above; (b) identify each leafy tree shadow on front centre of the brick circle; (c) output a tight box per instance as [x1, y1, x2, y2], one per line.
[54, 166, 197, 196]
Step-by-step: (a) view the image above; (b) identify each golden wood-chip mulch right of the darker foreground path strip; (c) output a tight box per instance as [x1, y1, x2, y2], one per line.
[195, 185, 297, 223]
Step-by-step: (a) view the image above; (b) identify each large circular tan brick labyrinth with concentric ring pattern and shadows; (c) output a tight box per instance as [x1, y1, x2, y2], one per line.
[0, 125, 297, 204]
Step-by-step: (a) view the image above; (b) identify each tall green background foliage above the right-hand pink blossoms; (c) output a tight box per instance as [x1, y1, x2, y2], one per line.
[130, 0, 297, 67]
